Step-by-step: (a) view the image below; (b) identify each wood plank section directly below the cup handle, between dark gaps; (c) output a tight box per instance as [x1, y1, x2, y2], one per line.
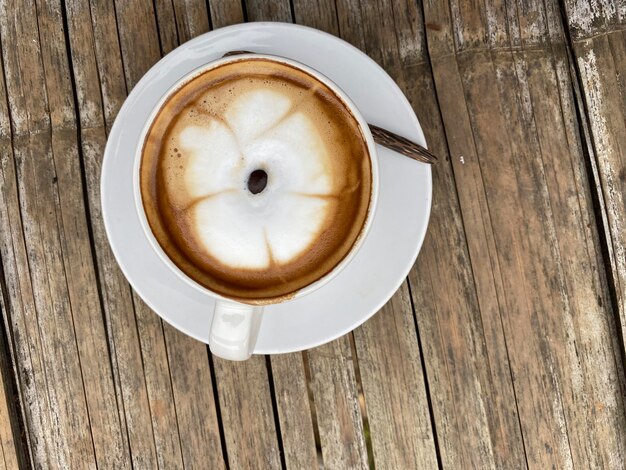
[213, 356, 281, 469]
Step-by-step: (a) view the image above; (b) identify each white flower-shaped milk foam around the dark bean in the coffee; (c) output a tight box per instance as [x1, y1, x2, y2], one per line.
[164, 83, 338, 270]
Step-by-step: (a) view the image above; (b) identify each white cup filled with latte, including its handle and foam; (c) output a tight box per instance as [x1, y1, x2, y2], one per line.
[133, 54, 378, 360]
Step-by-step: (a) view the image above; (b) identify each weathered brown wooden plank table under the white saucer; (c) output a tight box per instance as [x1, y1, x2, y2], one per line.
[0, 0, 626, 469]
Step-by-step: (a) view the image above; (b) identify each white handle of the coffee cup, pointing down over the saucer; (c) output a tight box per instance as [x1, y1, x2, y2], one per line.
[209, 299, 263, 361]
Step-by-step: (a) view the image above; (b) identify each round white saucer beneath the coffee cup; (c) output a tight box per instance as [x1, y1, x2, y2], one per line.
[101, 23, 432, 354]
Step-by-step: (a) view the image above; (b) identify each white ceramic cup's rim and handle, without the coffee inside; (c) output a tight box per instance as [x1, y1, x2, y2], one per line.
[133, 53, 379, 361]
